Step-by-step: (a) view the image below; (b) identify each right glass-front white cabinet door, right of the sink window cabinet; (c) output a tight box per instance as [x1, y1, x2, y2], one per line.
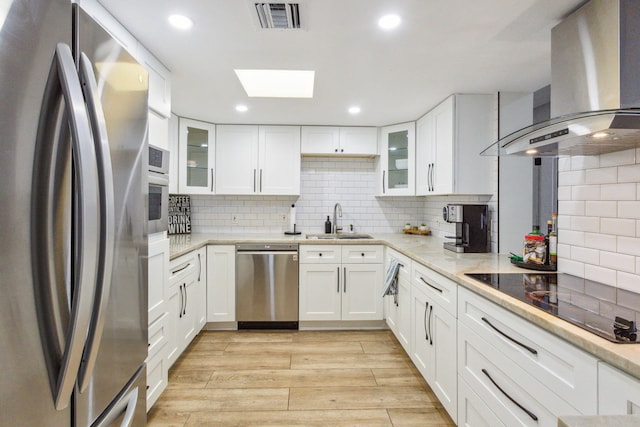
[378, 122, 416, 196]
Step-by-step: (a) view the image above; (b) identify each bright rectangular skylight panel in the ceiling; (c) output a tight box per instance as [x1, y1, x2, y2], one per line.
[234, 70, 315, 98]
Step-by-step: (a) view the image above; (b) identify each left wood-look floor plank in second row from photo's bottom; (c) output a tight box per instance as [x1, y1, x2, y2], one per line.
[156, 388, 289, 413]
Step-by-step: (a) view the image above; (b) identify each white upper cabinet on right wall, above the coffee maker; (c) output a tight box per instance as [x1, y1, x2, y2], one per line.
[416, 95, 496, 196]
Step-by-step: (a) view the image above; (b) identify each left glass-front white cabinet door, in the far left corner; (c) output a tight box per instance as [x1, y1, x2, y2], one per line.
[178, 118, 215, 194]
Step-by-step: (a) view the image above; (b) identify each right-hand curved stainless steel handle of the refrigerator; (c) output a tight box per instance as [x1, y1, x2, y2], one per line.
[79, 53, 115, 392]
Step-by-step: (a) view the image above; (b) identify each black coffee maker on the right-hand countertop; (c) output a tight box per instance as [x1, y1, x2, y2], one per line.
[442, 205, 491, 253]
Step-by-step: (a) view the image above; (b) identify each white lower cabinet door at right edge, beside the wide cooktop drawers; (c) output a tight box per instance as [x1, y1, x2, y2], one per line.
[598, 362, 640, 415]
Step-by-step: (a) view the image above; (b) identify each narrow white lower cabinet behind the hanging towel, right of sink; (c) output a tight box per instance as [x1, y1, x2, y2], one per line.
[384, 248, 412, 353]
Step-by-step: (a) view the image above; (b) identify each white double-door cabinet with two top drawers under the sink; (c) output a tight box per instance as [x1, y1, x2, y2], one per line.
[299, 245, 383, 321]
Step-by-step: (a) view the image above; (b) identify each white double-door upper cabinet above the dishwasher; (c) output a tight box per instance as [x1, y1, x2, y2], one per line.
[216, 125, 300, 195]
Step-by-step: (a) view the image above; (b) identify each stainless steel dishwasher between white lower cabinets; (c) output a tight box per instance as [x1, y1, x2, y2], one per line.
[236, 243, 298, 329]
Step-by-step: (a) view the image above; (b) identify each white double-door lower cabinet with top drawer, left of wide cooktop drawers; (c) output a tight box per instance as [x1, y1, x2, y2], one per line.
[409, 263, 458, 422]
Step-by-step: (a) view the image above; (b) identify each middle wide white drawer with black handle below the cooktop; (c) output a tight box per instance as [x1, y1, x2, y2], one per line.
[458, 325, 580, 427]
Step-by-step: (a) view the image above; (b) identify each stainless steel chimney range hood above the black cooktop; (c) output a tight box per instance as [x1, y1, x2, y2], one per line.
[496, 0, 640, 157]
